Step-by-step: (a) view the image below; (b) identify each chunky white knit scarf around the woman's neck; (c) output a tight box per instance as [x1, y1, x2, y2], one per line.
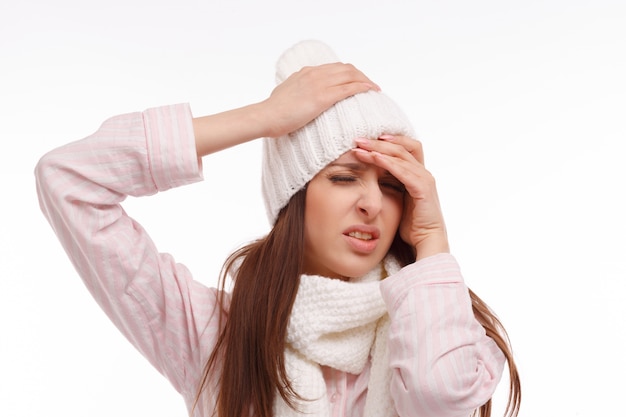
[274, 257, 400, 417]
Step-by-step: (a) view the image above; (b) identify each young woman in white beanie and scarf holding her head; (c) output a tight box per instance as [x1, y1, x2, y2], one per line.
[36, 41, 521, 417]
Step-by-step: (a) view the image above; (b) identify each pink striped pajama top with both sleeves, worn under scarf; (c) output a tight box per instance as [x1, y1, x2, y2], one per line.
[35, 104, 505, 417]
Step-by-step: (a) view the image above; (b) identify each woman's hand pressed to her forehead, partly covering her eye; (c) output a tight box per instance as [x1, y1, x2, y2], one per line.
[353, 135, 450, 260]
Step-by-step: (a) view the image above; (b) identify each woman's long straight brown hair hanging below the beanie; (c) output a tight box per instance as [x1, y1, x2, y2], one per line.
[192, 188, 521, 417]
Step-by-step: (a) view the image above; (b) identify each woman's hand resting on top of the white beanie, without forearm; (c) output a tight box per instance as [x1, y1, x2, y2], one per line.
[260, 62, 380, 137]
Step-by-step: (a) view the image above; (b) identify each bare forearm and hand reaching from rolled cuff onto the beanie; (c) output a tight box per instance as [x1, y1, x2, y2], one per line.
[193, 63, 380, 157]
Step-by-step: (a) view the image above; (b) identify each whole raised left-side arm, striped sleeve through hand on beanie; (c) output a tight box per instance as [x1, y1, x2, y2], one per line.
[35, 64, 374, 391]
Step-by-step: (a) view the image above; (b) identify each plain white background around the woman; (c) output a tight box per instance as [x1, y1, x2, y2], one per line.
[0, 0, 626, 417]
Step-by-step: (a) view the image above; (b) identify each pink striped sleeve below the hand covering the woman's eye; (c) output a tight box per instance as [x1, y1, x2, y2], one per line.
[381, 253, 505, 417]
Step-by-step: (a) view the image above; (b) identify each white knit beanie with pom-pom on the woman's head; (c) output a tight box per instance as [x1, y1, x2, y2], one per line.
[262, 40, 415, 224]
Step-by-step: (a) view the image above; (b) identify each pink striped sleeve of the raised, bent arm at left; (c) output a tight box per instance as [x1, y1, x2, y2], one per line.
[35, 105, 217, 391]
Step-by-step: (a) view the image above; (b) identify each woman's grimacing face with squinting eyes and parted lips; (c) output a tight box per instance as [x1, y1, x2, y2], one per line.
[304, 152, 404, 279]
